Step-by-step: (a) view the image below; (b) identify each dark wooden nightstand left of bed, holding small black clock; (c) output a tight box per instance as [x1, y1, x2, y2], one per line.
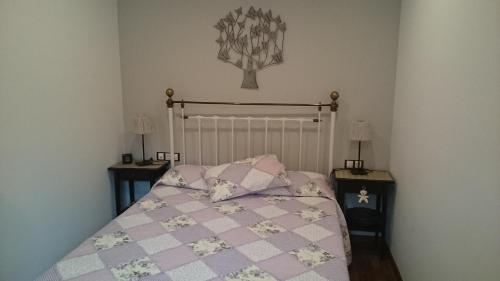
[108, 161, 170, 216]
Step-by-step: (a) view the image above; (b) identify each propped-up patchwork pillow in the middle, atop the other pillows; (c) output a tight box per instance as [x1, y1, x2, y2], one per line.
[205, 155, 290, 202]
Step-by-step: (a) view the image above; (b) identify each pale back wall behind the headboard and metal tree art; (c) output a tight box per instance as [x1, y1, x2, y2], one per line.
[118, 0, 400, 171]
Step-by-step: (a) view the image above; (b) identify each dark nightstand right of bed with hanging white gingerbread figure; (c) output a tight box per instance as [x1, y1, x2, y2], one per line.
[332, 169, 395, 245]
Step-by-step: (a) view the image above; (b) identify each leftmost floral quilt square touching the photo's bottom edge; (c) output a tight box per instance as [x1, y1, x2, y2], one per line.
[111, 257, 160, 281]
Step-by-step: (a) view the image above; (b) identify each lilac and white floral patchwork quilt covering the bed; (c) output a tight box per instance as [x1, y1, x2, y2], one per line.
[37, 172, 350, 281]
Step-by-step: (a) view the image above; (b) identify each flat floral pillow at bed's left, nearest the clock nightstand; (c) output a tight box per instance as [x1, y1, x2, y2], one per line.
[157, 165, 208, 190]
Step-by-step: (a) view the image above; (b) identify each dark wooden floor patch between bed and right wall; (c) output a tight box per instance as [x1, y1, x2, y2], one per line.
[349, 236, 402, 281]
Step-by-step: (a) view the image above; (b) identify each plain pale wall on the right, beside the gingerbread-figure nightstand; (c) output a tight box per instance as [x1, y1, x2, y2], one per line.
[390, 0, 500, 281]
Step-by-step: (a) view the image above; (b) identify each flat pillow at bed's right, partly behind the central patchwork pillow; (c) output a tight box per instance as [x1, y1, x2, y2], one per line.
[258, 171, 335, 199]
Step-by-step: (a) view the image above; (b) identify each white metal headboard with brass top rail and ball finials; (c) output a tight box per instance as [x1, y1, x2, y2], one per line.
[165, 88, 339, 173]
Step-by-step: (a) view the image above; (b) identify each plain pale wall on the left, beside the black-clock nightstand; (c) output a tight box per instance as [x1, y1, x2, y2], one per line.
[0, 0, 123, 281]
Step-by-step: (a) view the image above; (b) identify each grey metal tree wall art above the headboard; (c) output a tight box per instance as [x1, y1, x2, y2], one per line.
[215, 7, 286, 89]
